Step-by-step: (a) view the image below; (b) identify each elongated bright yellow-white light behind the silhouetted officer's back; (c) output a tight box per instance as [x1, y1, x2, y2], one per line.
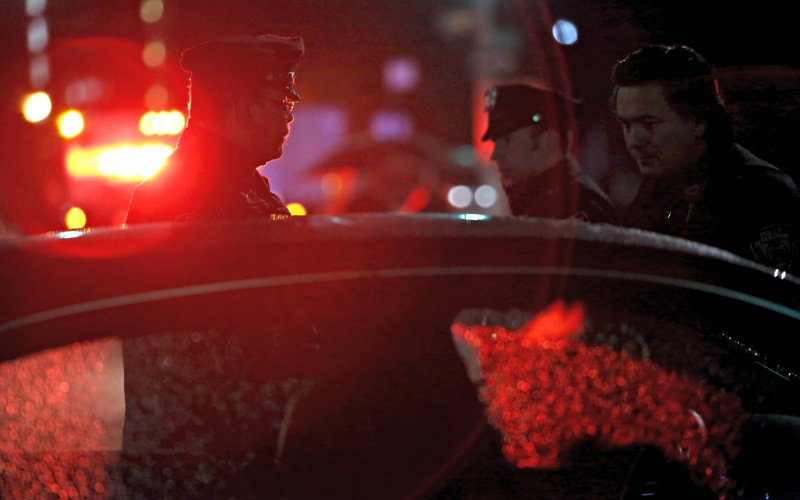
[66, 143, 173, 182]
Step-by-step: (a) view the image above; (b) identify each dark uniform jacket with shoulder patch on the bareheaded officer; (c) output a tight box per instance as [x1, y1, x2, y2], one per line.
[623, 145, 800, 274]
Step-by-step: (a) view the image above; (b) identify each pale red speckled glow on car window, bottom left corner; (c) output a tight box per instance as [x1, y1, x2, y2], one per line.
[0, 340, 125, 498]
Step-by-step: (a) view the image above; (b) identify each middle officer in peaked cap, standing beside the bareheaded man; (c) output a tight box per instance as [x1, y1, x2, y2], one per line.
[482, 84, 615, 223]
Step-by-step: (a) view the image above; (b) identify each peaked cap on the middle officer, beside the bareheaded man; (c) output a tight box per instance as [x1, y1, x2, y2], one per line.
[481, 84, 581, 141]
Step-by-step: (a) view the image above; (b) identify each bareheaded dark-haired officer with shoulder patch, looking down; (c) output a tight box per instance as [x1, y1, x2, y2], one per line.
[611, 45, 800, 272]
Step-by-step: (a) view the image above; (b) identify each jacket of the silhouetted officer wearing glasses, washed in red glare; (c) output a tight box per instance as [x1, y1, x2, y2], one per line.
[126, 130, 289, 224]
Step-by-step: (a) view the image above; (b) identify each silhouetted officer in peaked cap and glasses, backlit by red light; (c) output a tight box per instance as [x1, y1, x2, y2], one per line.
[127, 35, 304, 223]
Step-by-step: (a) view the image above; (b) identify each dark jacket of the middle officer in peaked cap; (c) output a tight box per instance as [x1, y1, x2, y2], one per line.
[506, 161, 617, 224]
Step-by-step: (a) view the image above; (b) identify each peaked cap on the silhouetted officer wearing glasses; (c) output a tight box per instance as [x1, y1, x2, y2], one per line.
[181, 35, 304, 100]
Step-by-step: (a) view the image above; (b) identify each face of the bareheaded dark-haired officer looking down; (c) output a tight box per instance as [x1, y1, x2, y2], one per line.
[616, 83, 708, 176]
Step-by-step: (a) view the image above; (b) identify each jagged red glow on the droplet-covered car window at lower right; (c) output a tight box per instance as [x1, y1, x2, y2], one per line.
[453, 302, 743, 493]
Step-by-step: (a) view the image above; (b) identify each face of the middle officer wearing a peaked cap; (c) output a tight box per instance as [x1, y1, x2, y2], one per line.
[492, 125, 550, 188]
